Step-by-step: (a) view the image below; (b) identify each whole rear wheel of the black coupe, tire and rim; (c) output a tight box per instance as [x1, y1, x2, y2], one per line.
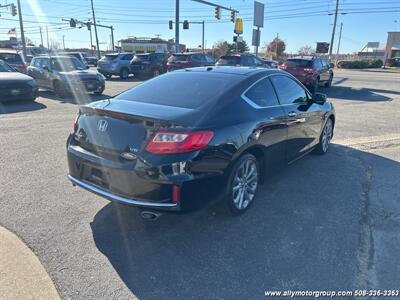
[225, 154, 260, 215]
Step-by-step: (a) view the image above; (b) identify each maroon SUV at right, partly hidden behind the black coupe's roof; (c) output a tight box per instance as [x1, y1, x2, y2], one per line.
[279, 56, 333, 92]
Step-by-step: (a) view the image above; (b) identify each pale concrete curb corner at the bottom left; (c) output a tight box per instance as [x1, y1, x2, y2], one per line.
[0, 226, 60, 300]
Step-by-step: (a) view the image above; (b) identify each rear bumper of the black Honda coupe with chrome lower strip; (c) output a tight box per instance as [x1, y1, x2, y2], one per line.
[67, 143, 223, 212]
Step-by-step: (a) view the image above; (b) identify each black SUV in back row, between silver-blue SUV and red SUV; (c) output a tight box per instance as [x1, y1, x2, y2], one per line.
[130, 53, 167, 77]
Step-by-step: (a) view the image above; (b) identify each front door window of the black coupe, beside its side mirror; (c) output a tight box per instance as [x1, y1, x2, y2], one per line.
[270, 75, 308, 105]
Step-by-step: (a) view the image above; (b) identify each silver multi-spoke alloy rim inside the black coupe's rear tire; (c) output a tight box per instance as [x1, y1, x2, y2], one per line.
[232, 159, 258, 210]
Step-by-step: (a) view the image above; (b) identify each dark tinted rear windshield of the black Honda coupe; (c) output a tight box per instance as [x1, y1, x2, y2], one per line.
[115, 72, 241, 109]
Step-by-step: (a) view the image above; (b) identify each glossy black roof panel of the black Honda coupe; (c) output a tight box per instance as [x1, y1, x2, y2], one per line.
[174, 66, 283, 76]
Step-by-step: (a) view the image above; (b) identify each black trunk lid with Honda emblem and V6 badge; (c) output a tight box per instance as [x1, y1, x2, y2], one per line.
[75, 100, 191, 159]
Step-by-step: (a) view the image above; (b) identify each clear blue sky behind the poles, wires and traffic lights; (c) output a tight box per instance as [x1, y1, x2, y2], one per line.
[0, 0, 400, 53]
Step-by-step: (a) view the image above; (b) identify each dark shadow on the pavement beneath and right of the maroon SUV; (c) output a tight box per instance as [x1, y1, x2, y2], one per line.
[318, 85, 394, 102]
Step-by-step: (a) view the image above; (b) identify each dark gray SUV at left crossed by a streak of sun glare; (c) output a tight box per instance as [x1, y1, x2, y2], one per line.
[28, 56, 105, 97]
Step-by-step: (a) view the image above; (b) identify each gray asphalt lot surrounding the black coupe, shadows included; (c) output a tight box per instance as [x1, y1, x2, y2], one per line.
[0, 70, 400, 299]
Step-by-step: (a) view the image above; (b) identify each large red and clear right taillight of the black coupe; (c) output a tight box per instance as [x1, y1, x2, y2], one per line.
[146, 131, 214, 154]
